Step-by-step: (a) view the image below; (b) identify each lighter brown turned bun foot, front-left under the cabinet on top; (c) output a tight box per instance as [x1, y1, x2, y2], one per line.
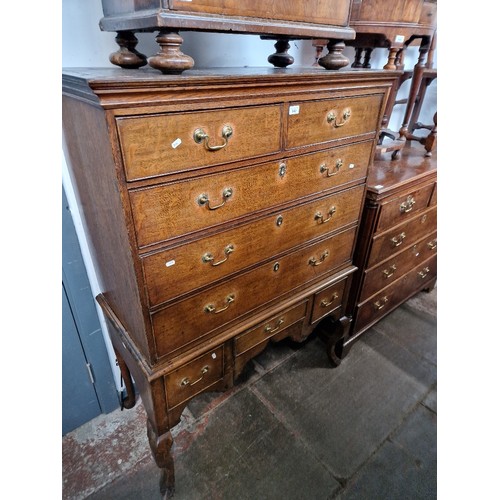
[148, 30, 194, 74]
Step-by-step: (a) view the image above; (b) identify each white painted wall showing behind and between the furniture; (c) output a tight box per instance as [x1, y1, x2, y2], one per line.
[62, 0, 437, 387]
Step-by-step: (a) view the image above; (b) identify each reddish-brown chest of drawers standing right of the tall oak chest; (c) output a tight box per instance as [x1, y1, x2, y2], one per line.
[344, 144, 437, 348]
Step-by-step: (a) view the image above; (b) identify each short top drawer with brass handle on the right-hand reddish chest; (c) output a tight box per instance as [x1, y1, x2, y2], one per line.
[377, 184, 434, 231]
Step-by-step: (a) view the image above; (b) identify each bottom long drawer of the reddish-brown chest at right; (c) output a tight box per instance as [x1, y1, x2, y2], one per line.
[355, 256, 437, 331]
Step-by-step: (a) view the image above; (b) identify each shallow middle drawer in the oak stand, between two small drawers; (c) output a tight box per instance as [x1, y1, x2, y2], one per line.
[234, 302, 307, 356]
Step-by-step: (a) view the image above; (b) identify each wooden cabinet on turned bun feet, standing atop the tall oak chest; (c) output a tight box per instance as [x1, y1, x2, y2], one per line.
[100, 0, 355, 73]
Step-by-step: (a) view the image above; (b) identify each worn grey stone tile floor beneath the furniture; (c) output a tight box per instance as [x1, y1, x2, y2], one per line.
[62, 289, 437, 500]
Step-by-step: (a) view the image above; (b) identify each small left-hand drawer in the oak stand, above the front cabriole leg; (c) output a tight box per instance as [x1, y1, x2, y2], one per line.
[164, 346, 224, 408]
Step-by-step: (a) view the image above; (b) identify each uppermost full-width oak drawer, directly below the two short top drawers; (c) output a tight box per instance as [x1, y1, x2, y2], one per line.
[130, 142, 372, 247]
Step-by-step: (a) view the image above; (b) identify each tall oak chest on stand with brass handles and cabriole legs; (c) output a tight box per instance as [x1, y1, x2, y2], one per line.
[63, 69, 399, 492]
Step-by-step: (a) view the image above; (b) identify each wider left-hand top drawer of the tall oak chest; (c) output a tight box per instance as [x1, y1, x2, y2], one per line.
[116, 104, 281, 181]
